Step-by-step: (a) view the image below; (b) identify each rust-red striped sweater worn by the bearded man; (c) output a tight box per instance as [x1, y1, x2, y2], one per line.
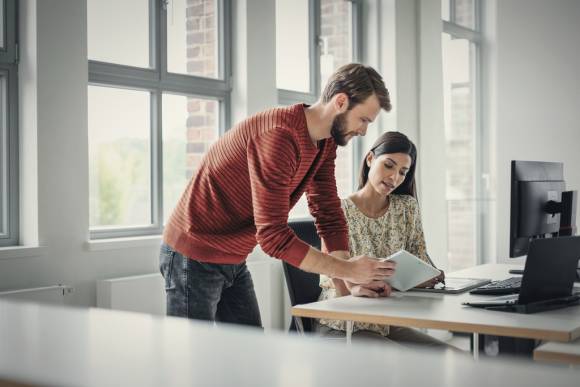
[163, 104, 348, 266]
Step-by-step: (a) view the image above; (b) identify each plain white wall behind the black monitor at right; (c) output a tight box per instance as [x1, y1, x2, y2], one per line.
[491, 0, 580, 261]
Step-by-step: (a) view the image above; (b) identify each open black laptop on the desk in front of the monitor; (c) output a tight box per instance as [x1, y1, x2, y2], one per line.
[463, 236, 580, 313]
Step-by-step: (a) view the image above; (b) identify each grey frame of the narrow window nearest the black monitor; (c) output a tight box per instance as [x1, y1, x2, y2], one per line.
[441, 0, 482, 265]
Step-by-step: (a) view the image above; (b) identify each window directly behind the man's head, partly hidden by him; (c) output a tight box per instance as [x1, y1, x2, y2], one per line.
[276, 0, 362, 218]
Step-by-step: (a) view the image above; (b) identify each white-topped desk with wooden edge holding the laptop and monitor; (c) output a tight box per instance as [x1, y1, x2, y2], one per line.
[292, 264, 580, 356]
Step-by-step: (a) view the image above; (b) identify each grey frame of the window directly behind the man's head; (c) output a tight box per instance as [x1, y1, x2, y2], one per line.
[278, 0, 363, 221]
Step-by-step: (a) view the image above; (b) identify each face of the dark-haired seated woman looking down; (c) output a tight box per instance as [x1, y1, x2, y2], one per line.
[366, 152, 412, 195]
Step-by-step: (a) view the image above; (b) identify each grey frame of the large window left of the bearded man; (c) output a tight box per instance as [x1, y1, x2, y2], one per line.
[87, 0, 232, 240]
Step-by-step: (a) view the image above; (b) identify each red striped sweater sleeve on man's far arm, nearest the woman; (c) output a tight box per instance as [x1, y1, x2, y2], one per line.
[306, 140, 348, 252]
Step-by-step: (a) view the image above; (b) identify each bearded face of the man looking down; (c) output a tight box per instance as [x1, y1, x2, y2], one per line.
[330, 94, 381, 146]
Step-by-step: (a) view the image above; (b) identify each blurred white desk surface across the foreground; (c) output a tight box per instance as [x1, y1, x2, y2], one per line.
[0, 301, 580, 387]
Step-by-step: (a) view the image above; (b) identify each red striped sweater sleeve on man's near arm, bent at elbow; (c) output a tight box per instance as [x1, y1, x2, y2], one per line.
[247, 129, 310, 267]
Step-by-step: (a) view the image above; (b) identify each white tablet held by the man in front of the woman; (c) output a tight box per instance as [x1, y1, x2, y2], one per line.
[384, 250, 441, 292]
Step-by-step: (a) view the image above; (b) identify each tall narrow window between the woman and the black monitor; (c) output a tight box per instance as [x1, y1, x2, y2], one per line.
[442, 0, 486, 270]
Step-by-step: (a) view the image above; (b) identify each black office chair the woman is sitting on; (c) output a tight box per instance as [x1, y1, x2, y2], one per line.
[282, 221, 321, 332]
